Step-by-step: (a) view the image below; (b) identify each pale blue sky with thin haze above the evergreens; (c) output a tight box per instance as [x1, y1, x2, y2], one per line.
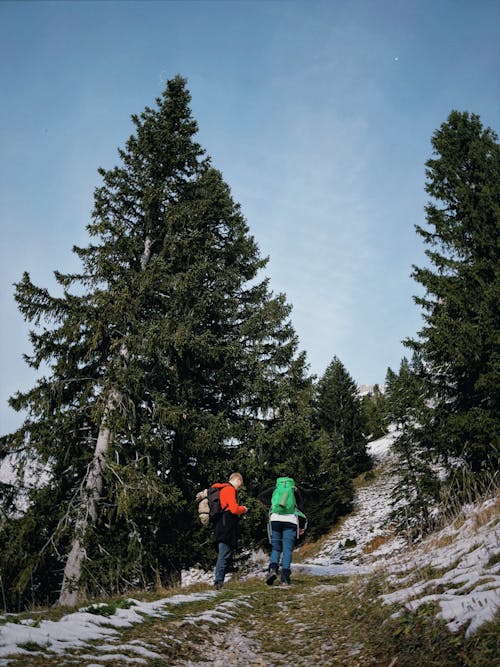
[0, 0, 500, 434]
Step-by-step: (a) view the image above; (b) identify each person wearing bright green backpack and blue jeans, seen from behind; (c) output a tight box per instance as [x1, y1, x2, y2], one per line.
[257, 477, 307, 586]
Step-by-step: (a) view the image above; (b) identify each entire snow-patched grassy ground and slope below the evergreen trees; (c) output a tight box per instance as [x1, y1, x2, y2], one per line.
[0, 436, 500, 667]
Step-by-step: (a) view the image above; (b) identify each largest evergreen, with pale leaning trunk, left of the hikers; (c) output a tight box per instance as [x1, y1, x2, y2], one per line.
[0, 77, 308, 606]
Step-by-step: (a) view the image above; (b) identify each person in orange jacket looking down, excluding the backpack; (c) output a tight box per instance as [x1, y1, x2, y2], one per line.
[213, 472, 248, 590]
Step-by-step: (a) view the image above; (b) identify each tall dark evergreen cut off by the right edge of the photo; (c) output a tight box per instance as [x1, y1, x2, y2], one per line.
[407, 111, 500, 471]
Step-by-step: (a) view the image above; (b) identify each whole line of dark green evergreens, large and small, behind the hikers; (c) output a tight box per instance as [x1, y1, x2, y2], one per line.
[0, 77, 499, 610]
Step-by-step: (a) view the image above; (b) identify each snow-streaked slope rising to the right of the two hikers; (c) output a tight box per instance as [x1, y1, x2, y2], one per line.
[300, 436, 500, 635]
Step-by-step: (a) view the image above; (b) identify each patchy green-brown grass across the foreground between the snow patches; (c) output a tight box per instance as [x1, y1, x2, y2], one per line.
[2, 575, 500, 667]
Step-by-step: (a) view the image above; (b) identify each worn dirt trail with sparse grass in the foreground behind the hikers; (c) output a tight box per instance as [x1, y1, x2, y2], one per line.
[164, 578, 377, 667]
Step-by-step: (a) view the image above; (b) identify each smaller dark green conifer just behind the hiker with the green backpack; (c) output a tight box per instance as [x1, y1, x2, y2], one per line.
[268, 358, 371, 538]
